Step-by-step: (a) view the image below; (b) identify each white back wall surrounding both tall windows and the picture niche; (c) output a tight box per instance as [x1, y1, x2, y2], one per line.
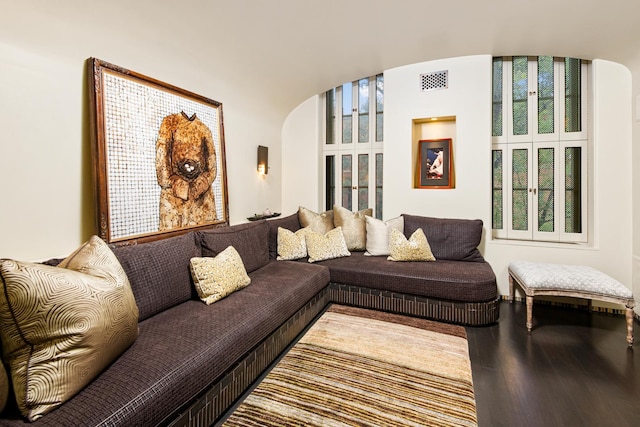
[283, 55, 639, 312]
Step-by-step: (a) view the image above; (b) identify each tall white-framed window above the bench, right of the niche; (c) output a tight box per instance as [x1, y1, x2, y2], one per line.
[491, 56, 589, 242]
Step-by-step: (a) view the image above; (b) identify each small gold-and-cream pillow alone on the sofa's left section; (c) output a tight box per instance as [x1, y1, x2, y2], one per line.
[190, 246, 251, 305]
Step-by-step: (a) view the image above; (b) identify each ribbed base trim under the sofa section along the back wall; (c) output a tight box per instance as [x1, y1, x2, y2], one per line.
[329, 282, 500, 326]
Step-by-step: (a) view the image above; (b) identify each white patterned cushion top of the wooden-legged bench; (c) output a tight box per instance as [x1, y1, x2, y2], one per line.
[509, 261, 633, 298]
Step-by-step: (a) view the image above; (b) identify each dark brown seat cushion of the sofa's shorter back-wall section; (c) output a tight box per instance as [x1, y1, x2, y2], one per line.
[318, 252, 498, 302]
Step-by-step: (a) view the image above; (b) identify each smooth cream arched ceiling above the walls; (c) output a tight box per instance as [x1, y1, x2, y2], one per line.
[5, 0, 640, 114]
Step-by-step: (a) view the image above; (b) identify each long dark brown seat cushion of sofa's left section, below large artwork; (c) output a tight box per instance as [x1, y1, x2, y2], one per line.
[3, 261, 329, 426]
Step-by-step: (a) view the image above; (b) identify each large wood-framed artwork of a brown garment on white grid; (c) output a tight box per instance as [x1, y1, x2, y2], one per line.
[89, 58, 229, 244]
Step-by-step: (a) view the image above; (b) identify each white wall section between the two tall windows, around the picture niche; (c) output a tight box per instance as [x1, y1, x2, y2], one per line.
[383, 56, 492, 222]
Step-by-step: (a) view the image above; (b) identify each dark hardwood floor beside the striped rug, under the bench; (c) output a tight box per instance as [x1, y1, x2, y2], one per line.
[466, 302, 640, 427]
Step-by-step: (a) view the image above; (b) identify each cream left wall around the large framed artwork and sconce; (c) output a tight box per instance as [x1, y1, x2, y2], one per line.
[0, 40, 284, 261]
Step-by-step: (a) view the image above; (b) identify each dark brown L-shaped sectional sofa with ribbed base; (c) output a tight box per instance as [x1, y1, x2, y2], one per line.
[0, 214, 498, 426]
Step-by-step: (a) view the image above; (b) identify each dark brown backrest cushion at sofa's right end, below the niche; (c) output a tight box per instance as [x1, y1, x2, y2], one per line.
[402, 214, 484, 261]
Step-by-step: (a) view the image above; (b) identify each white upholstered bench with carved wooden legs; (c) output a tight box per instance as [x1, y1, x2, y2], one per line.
[509, 261, 635, 346]
